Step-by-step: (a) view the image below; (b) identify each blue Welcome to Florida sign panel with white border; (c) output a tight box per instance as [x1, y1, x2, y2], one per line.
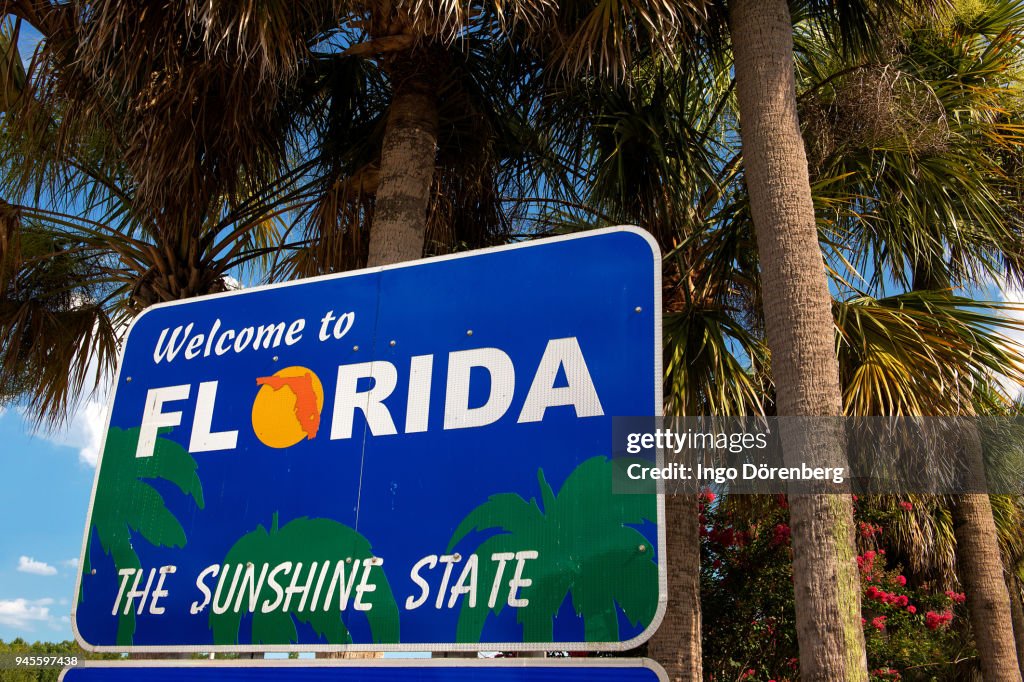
[73, 228, 666, 651]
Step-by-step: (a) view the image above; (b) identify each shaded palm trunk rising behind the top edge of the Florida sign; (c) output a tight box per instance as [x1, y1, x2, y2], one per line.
[367, 54, 437, 267]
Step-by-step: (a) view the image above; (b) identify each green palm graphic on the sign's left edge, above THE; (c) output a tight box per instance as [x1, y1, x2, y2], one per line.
[79, 427, 204, 646]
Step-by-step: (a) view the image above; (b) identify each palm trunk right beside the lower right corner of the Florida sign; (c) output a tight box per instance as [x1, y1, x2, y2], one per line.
[647, 493, 703, 682]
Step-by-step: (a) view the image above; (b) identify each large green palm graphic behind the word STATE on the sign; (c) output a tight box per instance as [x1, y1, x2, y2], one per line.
[447, 457, 658, 642]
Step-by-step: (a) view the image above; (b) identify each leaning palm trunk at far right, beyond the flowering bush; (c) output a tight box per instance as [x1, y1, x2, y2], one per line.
[951, 493, 1021, 682]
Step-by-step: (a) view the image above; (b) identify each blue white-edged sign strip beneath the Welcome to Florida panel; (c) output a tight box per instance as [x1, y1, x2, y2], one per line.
[60, 658, 669, 682]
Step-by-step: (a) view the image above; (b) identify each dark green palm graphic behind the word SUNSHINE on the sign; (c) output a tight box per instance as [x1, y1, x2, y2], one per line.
[210, 513, 399, 644]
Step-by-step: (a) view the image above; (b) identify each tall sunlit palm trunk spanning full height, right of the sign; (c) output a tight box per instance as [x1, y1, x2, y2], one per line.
[729, 0, 867, 681]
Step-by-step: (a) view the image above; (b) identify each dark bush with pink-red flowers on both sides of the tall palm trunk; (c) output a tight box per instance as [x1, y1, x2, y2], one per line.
[700, 494, 976, 682]
